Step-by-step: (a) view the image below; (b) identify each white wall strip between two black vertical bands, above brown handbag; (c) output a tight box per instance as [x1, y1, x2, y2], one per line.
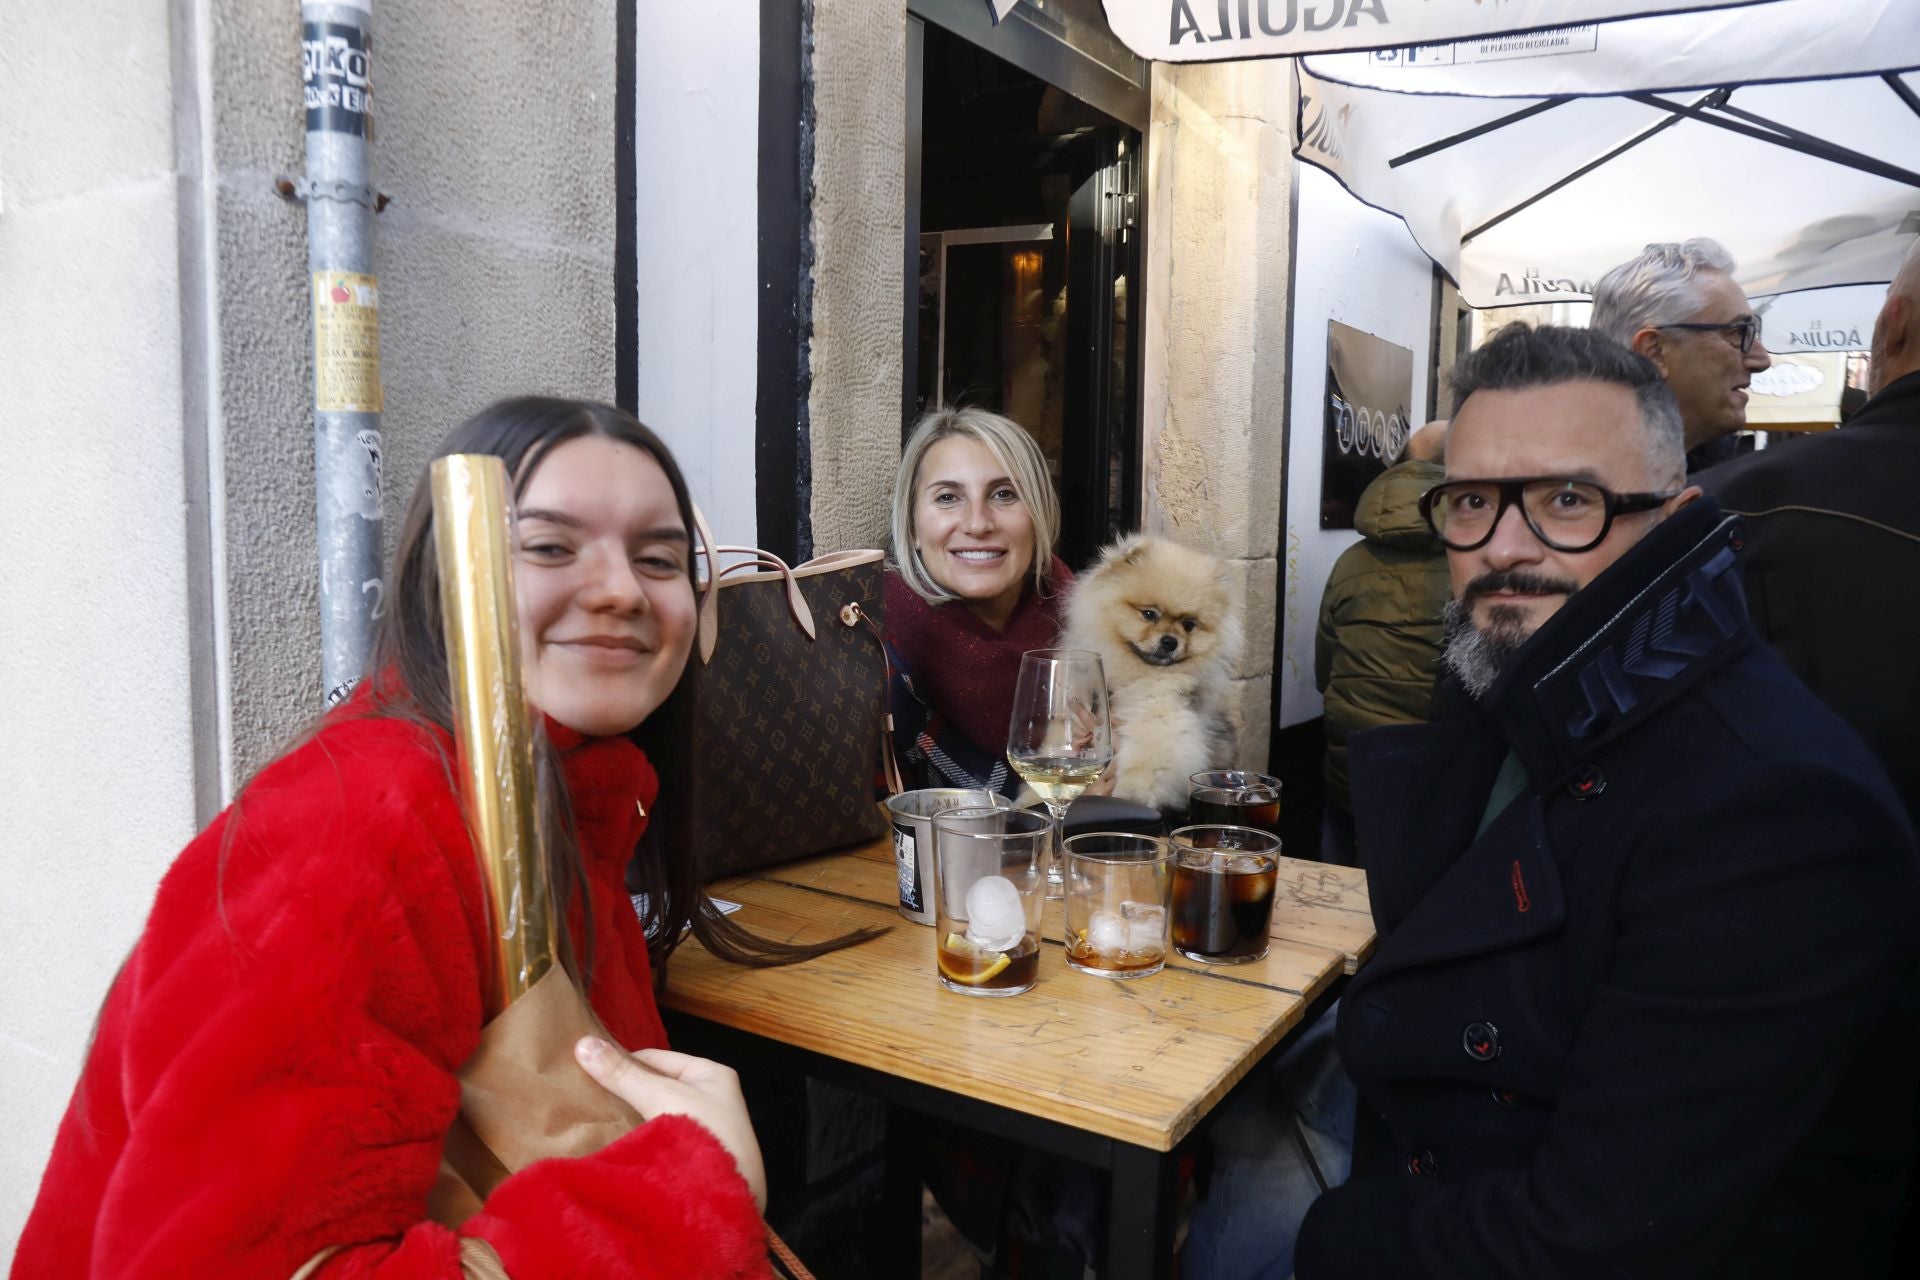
[634, 0, 760, 545]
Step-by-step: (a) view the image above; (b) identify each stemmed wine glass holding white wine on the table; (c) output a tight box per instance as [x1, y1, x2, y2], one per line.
[1006, 649, 1114, 898]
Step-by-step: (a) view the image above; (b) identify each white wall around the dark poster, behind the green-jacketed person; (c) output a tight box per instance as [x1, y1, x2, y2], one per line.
[1275, 165, 1434, 727]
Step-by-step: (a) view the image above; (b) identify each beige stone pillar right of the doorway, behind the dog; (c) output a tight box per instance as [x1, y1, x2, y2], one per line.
[1140, 61, 1294, 768]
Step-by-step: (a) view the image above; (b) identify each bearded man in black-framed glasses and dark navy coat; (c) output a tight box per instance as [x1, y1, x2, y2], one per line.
[1296, 326, 1920, 1280]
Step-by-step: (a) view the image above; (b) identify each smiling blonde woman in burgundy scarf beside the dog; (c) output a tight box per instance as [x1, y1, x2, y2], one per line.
[887, 409, 1073, 796]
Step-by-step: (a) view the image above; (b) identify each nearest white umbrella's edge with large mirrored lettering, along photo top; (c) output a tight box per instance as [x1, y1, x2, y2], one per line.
[1105, 0, 1776, 61]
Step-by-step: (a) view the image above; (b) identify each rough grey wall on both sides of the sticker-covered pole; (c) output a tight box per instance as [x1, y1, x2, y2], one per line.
[219, 0, 614, 781]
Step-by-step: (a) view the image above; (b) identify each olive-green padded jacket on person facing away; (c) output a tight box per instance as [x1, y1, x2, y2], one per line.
[1313, 459, 1448, 812]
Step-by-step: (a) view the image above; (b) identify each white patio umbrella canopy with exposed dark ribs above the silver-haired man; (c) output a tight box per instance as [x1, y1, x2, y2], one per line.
[1296, 0, 1920, 351]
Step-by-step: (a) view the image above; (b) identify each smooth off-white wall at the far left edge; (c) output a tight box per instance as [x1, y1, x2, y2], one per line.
[0, 0, 194, 1272]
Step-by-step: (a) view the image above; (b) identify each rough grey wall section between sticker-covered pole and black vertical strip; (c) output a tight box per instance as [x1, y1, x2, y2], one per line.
[374, 0, 614, 545]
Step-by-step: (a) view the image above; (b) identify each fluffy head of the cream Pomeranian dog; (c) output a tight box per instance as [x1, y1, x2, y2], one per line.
[1077, 541, 1233, 666]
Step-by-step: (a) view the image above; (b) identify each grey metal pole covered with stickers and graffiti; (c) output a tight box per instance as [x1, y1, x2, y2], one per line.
[294, 0, 386, 706]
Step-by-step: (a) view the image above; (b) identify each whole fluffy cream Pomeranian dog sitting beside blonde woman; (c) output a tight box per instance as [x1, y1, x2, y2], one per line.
[1060, 535, 1240, 810]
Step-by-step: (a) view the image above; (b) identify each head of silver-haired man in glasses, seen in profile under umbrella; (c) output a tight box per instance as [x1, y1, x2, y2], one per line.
[1592, 238, 1772, 472]
